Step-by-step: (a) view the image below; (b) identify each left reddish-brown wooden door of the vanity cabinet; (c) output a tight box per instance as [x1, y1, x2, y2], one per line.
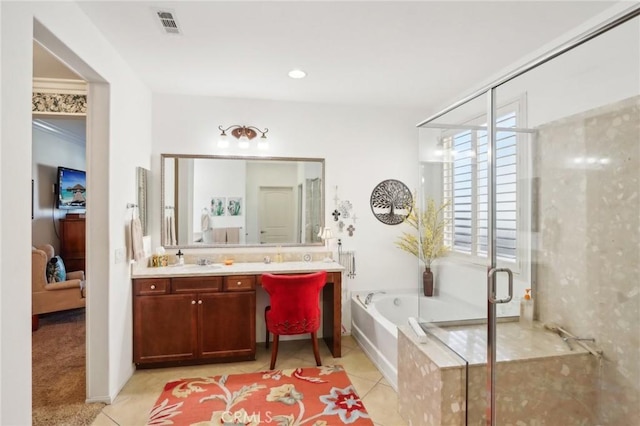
[133, 294, 198, 364]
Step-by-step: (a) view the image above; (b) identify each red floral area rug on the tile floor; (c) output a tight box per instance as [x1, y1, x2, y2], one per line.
[148, 365, 373, 426]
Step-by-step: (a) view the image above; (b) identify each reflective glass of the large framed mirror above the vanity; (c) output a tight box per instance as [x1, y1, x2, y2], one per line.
[161, 154, 325, 248]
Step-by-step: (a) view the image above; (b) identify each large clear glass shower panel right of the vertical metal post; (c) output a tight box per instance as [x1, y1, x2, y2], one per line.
[493, 11, 640, 425]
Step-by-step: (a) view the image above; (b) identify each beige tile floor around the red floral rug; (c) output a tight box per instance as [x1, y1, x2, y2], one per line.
[92, 336, 407, 426]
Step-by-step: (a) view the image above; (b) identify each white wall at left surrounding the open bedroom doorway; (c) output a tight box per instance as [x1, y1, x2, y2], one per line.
[0, 2, 151, 425]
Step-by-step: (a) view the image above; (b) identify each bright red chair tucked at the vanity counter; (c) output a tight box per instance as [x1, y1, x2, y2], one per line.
[262, 271, 327, 370]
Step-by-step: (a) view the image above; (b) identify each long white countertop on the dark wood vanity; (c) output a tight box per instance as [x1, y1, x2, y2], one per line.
[132, 261, 345, 278]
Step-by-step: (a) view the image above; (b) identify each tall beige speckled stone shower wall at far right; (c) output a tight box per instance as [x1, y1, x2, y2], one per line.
[534, 96, 640, 425]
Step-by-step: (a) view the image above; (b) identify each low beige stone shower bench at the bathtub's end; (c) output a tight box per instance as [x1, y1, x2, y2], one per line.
[398, 322, 600, 426]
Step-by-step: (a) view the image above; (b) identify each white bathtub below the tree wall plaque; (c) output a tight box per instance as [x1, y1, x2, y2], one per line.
[351, 291, 486, 391]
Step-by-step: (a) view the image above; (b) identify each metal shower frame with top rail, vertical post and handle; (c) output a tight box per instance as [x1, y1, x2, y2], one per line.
[416, 5, 640, 426]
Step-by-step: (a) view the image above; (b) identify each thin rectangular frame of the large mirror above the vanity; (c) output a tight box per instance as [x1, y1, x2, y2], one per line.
[160, 153, 326, 249]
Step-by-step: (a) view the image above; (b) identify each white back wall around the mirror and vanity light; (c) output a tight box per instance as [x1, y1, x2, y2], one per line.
[150, 94, 425, 326]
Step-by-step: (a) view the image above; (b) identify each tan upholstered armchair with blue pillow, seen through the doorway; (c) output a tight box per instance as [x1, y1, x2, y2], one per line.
[31, 244, 85, 328]
